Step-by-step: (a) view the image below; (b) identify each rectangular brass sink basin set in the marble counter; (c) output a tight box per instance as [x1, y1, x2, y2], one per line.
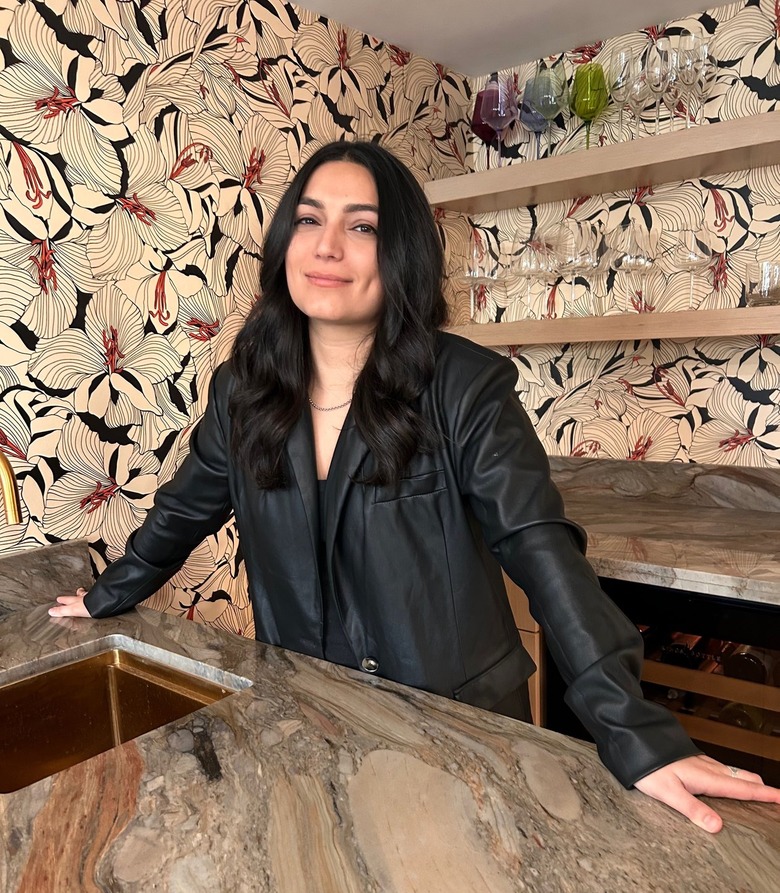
[0, 636, 251, 793]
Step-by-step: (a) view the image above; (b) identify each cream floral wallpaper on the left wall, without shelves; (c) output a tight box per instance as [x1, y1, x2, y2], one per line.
[0, 0, 470, 636]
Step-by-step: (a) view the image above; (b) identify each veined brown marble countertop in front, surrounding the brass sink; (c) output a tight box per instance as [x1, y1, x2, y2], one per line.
[0, 548, 780, 893]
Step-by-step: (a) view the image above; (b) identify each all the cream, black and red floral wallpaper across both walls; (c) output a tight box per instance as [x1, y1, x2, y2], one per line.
[0, 0, 780, 636]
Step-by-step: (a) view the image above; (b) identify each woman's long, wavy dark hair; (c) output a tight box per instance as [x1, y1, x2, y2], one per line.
[230, 142, 447, 489]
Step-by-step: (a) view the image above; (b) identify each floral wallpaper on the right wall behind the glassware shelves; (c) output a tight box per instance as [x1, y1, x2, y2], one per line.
[458, 0, 780, 468]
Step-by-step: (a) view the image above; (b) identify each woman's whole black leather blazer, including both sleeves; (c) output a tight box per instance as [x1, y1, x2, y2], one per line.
[86, 334, 696, 785]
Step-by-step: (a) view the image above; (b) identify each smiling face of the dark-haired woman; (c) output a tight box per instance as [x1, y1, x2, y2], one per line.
[285, 161, 382, 332]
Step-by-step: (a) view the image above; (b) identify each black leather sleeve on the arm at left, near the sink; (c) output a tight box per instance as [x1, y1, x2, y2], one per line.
[84, 366, 231, 617]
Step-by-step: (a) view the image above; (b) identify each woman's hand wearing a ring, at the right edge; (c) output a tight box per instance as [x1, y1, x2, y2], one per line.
[634, 755, 780, 834]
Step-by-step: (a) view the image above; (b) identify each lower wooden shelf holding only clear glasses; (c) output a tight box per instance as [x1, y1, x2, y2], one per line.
[447, 308, 780, 347]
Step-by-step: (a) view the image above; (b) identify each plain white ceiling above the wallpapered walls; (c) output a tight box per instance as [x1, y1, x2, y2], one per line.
[297, 0, 719, 76]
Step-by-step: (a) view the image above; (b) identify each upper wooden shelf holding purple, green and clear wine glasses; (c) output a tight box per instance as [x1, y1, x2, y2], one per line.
[425, 112, 780, 214]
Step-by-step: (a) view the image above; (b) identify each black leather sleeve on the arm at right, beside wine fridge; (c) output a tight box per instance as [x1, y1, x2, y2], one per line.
[455, 362, 699, 787]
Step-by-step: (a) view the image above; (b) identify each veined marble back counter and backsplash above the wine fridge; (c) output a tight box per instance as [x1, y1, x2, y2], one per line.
[551, 458, 780, 605]
